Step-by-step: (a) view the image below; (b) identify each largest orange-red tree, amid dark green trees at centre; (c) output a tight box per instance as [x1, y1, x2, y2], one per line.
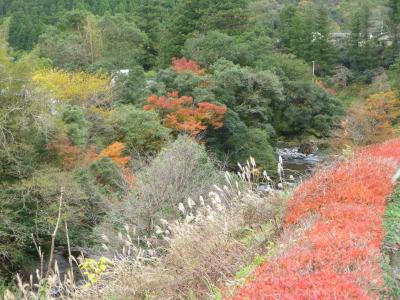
[144, 91, 227, 137]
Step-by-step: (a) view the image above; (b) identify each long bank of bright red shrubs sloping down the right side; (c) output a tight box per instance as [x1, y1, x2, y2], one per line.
[234, 139, 400, 299]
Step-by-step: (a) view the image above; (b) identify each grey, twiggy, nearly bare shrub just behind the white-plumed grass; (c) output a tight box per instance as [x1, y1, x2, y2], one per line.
[125, 136, 223, 231]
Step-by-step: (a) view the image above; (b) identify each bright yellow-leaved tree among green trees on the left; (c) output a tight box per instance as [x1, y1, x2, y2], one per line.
[32, 69, 111, 104]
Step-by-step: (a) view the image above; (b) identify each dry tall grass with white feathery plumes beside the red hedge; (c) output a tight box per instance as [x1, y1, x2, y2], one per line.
[5, 159, 287, 299]
